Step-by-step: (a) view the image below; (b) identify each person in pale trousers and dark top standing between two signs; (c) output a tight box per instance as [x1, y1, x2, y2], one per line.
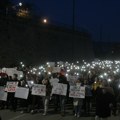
[42, 78, 52, 115]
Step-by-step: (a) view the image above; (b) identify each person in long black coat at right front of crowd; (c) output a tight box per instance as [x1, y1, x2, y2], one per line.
[95, 80, 114, 120]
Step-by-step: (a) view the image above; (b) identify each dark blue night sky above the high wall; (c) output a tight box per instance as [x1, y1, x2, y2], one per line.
[13, 0, 120, 42]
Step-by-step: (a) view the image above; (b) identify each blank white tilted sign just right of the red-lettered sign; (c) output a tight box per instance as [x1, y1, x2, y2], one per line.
[15, 87, 29, 99]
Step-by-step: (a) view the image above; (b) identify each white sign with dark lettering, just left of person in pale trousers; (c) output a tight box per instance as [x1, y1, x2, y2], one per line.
[32, 84, 46, 96]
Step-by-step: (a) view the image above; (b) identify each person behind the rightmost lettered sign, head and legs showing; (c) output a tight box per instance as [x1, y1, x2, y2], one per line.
[73, 80, 83, 117]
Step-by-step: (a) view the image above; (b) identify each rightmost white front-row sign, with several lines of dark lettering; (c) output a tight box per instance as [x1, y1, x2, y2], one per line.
[69, 86, 85, 98]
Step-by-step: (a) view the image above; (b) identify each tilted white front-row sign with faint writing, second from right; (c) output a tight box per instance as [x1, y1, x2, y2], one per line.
[52, 83, 67, 96]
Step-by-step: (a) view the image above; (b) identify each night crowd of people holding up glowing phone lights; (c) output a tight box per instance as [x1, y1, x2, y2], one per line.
[0, 60, 120, 120]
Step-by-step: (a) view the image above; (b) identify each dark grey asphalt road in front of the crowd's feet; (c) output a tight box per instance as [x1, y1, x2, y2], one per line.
[0, 110, 120, 120]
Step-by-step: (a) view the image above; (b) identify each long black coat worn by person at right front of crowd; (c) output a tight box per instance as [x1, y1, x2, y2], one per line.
[96, 87, 114, 118]
